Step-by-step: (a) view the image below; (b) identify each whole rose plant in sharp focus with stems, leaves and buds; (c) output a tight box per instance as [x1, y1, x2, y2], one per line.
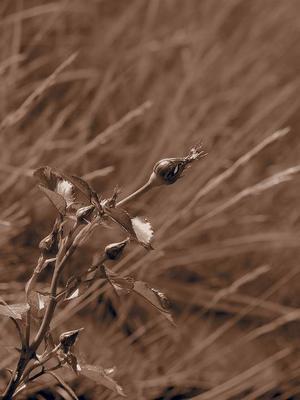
[0, 146, 205, 400]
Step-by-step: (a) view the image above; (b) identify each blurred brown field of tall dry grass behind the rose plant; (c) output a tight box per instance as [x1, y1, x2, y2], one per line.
[0, 0, 300, 400]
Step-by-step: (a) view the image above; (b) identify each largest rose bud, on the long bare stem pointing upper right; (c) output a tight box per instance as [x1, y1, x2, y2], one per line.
[149, 146, 206, 186]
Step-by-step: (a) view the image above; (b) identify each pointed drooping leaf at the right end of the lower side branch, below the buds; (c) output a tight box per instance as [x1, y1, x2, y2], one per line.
[133, 281, 174, 323]
